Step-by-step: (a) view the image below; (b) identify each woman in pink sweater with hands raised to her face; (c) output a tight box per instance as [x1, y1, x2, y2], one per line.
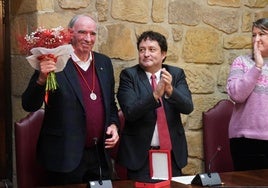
[227, 18, 268, 170]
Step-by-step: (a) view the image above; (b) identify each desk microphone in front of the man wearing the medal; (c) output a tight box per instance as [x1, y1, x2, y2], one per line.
[89, 137, 113, 188]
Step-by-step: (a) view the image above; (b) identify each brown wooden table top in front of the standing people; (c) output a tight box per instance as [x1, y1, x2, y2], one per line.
[40, 169, 268, 188]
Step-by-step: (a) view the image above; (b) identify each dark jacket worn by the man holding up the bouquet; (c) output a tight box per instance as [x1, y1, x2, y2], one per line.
[22, 52, 119, 172]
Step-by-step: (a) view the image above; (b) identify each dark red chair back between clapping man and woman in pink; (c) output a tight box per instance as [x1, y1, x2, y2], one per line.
[203, 99, 234, 172]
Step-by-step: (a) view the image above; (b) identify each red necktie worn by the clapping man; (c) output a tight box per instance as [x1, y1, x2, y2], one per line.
[151, 74, 172, 150]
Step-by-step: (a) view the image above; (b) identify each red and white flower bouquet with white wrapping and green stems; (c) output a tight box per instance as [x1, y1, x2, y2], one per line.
[18, 26, 73, 103]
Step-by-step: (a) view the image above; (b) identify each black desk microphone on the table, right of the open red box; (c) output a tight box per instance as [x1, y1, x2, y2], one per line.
[191, 145, 222, 186]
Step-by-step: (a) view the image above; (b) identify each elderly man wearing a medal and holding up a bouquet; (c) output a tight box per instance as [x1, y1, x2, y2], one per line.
[22, 15, 119, 185]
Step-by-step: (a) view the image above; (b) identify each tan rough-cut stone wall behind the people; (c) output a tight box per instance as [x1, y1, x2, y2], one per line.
[10, 0, 268, 184]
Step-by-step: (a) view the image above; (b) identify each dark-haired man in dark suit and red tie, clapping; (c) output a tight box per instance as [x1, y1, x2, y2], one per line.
[117, 31, 193, 180]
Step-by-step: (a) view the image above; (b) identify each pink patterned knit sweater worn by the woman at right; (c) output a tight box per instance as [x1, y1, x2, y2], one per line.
[227, 55, 268, 140]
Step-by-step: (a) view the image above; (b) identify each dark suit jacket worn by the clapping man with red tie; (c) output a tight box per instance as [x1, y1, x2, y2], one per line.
[117, 65, 193, 170]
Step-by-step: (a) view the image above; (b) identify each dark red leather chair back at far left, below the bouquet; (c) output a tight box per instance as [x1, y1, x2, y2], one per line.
[14, 109, 46, 188]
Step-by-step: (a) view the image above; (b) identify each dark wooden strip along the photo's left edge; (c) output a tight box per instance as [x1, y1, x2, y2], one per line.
[0, 0, 12, 181]
